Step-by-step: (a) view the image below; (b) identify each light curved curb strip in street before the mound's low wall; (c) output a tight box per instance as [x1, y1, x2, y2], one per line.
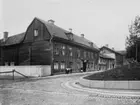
[65, 82, 140, 99]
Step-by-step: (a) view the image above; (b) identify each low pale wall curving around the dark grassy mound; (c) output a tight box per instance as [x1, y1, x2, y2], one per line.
[79, 77, 140, 89]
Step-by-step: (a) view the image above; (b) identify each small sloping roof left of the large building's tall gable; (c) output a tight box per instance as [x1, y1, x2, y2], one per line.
[1, 32, 25, 46]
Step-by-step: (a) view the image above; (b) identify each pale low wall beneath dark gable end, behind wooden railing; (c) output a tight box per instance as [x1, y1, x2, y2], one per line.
[0, 65, 51, 76]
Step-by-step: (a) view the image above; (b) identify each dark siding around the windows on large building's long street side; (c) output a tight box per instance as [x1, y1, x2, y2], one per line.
[54, 41, 99, 72]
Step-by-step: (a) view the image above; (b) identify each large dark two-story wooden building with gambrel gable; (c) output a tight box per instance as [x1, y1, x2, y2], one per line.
[0, 18, 99, 74]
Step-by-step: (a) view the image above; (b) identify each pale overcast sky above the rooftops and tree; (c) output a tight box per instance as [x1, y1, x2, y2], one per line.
[0, 0, 140, 50]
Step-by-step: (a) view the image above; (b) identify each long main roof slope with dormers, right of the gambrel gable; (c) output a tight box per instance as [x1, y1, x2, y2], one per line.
[36, 18, 99, 50]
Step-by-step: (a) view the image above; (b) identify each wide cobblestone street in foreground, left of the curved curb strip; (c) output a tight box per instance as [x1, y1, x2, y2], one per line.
[0, 74, 140, 105]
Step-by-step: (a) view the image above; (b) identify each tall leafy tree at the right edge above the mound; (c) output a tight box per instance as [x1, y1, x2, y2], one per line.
[126, 16, 140, 62]
